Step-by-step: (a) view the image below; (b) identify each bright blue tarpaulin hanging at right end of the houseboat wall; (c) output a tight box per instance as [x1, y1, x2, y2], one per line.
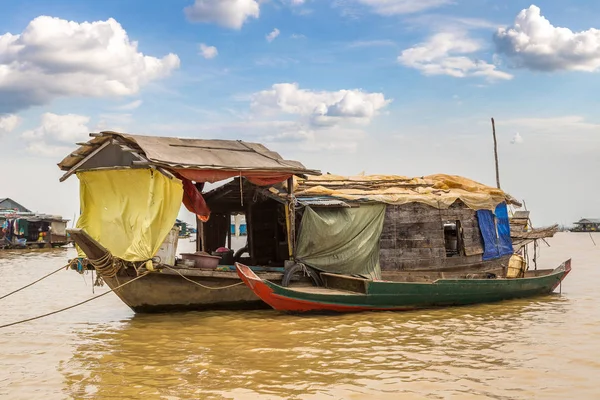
[477, 203, 513, 260]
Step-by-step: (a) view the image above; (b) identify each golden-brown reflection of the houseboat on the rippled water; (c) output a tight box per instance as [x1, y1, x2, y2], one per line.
[61, 297, 568, 398]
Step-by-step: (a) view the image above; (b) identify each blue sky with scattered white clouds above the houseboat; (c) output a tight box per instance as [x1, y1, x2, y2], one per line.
[0, 0, 600, 226]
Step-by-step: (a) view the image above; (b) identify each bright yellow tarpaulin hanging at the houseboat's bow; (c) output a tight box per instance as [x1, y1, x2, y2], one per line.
[77, 169, 183, 261]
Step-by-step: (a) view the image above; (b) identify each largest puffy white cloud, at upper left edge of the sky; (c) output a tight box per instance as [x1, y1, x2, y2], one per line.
[0, 16, 179, 113]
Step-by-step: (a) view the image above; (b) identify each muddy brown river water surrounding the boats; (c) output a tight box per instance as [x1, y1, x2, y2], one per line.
[0, 233, 600, 400]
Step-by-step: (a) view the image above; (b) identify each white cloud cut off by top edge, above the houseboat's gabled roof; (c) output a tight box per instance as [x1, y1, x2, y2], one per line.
[184, 0, 260, 29]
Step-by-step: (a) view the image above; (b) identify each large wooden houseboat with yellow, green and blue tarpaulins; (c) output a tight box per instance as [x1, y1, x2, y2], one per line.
[59, 132, 564, 312]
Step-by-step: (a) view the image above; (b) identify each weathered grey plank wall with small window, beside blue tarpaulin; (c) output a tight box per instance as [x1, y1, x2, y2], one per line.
[379, 201, 483, 271]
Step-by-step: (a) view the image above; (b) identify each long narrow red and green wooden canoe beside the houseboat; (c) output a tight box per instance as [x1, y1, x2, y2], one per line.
[236, 259, 571, 312]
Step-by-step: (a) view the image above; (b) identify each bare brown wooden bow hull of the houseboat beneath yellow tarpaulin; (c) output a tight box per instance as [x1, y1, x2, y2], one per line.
[104, 269, 282, 313]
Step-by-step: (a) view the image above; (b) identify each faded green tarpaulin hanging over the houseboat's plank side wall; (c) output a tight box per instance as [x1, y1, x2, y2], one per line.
[296, 204, 385, 279]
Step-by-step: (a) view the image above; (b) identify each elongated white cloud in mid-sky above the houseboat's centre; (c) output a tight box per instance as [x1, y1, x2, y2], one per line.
[251, 83, 391, 125]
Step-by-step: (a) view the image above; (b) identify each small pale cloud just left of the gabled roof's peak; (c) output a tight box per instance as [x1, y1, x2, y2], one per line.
[22, 113, 90, 156]
